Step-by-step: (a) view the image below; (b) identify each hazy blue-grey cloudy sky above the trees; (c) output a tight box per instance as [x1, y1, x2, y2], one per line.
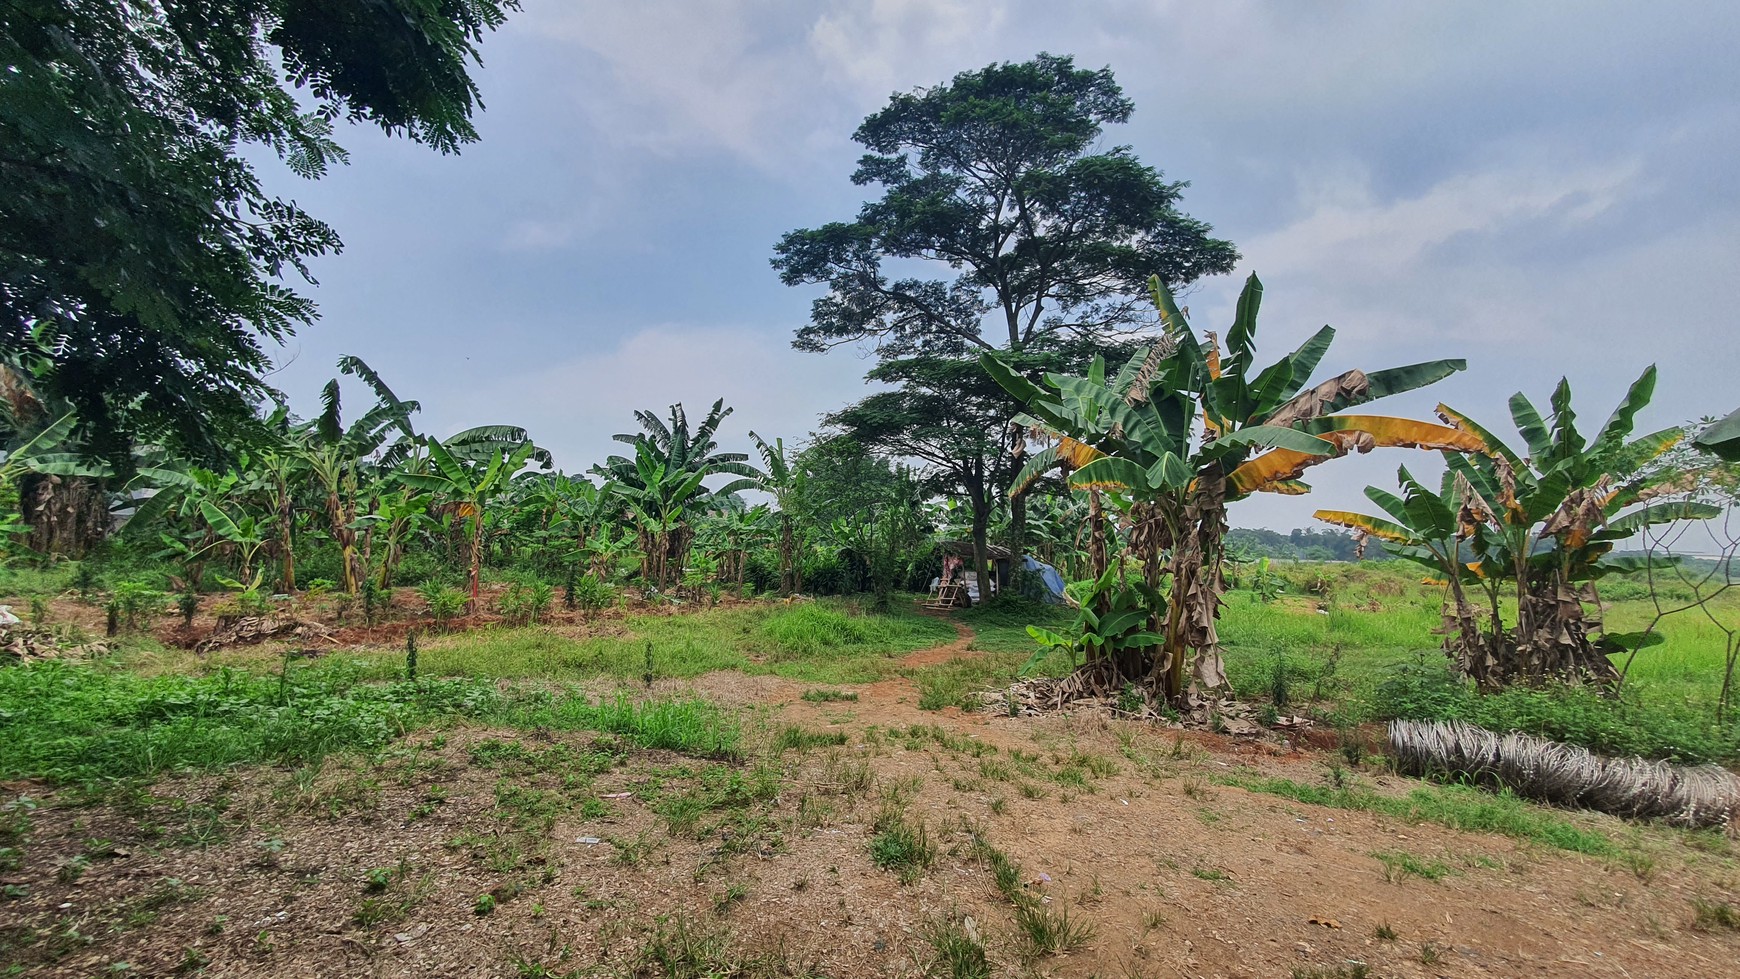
[266, 0, 1740, 530]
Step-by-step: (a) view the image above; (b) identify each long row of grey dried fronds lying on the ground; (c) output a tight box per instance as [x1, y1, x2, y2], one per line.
[1390, 720, 1740, 828]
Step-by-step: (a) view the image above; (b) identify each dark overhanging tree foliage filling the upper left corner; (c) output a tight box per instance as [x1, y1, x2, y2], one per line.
[0, 0, 519, 464]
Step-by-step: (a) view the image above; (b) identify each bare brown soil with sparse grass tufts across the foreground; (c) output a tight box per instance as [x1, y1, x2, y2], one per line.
[0, 615, 1740, 979]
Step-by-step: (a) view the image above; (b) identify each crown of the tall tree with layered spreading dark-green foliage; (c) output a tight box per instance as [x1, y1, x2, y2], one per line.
[773, 54, 1239, 598]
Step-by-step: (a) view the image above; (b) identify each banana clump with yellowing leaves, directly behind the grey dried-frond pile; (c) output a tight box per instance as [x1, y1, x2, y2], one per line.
[1317, 365, 1723, 689]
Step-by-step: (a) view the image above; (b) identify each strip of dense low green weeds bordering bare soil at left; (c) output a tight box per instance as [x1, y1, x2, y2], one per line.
[0, 659, 740, 783]
